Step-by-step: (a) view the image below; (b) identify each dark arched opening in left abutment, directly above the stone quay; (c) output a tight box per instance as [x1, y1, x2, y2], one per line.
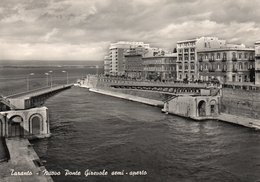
[8, 115, 23, 137]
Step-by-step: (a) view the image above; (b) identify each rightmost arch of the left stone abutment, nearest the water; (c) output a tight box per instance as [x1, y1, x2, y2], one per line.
[29, 114, 43, 135]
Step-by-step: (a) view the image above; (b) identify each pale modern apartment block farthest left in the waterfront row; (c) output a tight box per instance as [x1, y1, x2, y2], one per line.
[104, 41, 150, 75]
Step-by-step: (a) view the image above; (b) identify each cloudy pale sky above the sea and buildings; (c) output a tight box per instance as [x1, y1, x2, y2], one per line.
[0, 0, 260, 60]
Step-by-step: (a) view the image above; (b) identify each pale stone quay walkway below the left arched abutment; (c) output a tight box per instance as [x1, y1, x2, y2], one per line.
[0, 138, 53, 182]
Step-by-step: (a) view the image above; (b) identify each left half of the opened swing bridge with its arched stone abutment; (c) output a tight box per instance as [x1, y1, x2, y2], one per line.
[0, 84, 72, 139]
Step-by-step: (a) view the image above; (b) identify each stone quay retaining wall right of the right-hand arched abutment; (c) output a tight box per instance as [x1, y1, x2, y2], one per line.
[221, 88, 260, 119]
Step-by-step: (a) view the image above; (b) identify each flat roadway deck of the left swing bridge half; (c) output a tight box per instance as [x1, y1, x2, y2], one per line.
[7, 84, 73, 99]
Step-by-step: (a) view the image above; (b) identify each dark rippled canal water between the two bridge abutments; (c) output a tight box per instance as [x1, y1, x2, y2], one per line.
[33, 87, 260, 182]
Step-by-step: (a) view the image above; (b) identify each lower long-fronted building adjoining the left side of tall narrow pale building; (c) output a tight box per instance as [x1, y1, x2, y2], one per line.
[143, 54, 177, 81]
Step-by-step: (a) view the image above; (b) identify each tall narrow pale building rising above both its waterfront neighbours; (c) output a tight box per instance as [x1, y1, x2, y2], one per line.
[177, 37, 226, 81]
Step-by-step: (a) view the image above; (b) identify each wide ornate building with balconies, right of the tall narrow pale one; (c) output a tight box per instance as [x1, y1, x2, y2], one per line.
[197, 44, 255, 83]
